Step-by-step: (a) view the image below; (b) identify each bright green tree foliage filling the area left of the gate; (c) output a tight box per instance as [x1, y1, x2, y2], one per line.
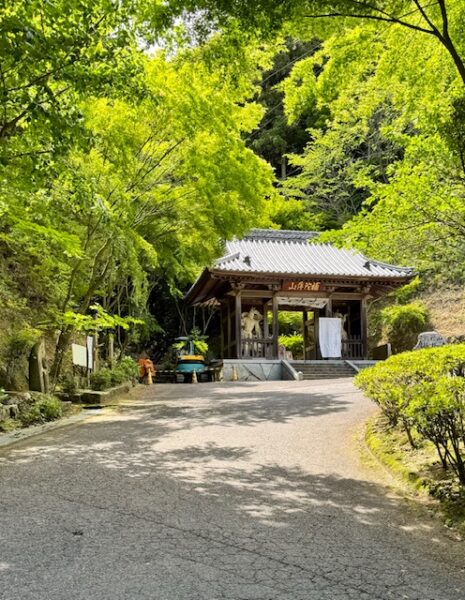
[0, 0, 273, 381]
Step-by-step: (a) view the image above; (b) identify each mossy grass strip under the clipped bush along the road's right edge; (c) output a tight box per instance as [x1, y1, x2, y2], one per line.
[365, 415, 465, 533]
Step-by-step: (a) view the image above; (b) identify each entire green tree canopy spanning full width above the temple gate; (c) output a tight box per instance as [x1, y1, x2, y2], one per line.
[0, 0, 465, 384]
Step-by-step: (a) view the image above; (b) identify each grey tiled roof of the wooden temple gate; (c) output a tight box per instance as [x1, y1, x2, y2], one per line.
[213, 229, 415, 279]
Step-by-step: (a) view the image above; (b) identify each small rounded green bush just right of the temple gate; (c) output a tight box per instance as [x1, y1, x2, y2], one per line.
[381, 302, 428, 354]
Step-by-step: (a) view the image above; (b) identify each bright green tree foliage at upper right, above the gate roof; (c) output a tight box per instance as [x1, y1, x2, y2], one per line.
[179, 0, 465, 282]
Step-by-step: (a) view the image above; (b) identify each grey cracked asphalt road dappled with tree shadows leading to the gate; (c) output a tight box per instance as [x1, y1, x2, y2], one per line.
[0, 380, 465, 600]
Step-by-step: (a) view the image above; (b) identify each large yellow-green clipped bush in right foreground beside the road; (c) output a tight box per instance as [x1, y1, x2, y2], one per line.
[355, 344, 465, 485]
